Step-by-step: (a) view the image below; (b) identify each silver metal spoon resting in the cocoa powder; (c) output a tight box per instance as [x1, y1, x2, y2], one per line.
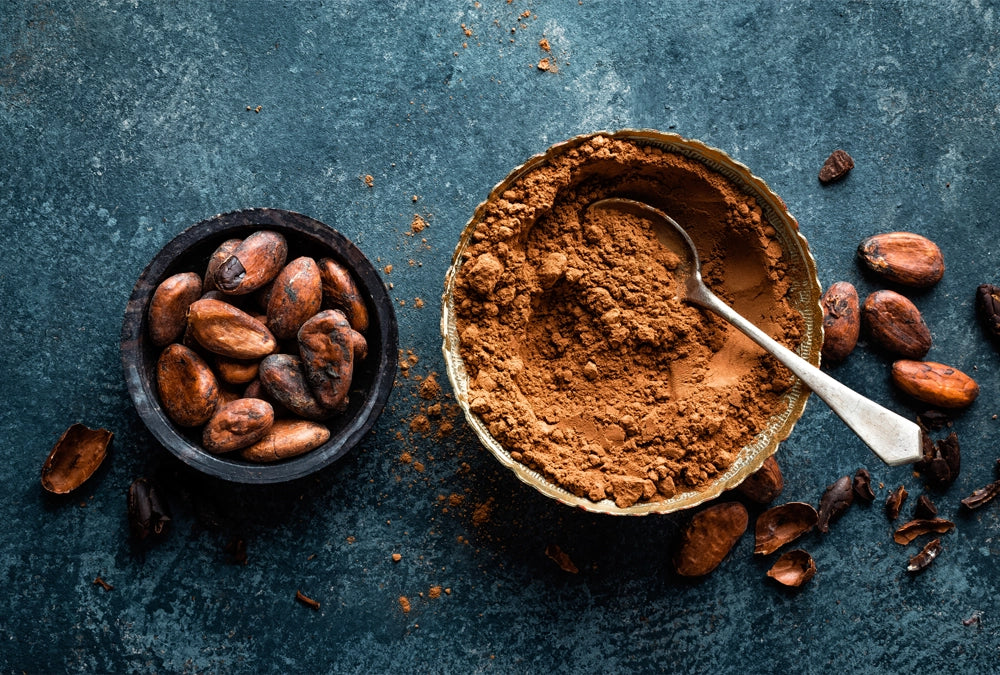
[587, 197, 923, 466]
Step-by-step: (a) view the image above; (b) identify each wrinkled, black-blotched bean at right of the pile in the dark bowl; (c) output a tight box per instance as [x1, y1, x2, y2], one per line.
[299, 309, 368, 410]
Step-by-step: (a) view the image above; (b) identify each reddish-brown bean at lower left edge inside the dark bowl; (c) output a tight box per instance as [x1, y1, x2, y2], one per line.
[156, 343, 219, 427]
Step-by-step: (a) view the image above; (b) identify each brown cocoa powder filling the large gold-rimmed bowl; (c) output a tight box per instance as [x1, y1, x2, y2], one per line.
[454, 136, 804, 507]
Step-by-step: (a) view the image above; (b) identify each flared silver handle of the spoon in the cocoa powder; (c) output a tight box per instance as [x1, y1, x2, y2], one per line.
[688, 285, 923, 466]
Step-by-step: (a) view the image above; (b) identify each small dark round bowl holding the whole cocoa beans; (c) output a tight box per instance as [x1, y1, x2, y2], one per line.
[121, 208, 399, 484]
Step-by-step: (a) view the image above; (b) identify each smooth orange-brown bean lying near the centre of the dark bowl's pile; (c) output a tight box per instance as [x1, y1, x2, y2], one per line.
[188, 300, 278, 359]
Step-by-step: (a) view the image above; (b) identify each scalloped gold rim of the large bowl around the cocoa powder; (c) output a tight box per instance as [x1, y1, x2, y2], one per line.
[440, 129, 823, 516]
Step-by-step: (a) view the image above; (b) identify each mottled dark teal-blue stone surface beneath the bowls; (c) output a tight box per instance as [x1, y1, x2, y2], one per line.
[0, 0, 1000, 673]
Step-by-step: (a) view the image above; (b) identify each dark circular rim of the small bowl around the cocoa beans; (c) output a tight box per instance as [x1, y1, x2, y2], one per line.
[120, 207, 399, 484]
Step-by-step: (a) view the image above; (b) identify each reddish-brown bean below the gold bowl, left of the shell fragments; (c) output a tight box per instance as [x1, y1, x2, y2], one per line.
[674, 502, 749, 577]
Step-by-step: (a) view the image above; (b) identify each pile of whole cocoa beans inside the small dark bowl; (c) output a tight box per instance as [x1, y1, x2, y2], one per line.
[148, 230, 368, 462]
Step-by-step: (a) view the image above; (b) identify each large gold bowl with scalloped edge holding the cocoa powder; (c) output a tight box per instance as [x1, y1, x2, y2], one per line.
[441, 130, 823, 515]
